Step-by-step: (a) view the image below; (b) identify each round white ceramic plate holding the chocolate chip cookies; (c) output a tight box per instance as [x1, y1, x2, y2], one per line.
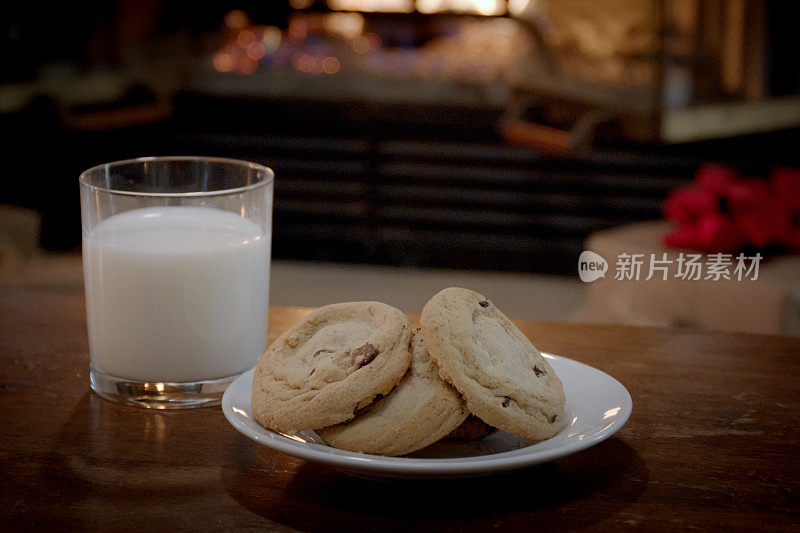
[222, 354, 633, 479]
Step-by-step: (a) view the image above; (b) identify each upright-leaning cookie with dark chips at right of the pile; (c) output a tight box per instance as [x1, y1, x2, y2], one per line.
[420, 287, 565, 440]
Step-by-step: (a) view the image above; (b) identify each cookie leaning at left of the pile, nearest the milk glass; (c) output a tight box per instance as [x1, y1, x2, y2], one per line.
[251, 302, 411, 432]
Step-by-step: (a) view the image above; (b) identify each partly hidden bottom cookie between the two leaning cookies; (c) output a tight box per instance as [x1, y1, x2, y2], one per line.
[316, 331, 469, 455]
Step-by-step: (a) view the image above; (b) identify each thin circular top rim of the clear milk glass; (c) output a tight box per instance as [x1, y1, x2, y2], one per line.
[78, 155, 275, 198]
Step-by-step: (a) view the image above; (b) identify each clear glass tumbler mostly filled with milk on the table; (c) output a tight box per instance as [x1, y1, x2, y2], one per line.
[80, 157, 274, 409]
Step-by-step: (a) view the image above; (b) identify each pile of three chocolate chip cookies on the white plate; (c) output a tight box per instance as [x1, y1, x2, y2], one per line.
[252, 287, 564, 455]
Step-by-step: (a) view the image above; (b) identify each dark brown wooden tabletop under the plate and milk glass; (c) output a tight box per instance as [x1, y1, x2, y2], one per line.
[0, 291, 800, 531]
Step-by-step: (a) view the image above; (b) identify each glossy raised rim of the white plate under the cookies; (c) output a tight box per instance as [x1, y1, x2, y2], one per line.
[221, 352, 633, 477]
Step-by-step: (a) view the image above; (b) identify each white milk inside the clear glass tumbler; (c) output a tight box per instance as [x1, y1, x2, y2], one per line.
[83, 207, 270, 382]
